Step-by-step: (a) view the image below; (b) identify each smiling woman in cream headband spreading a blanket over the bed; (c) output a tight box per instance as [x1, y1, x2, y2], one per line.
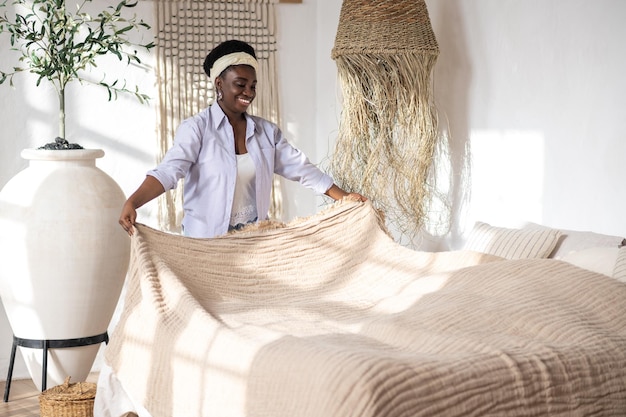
[119, 40, 365, 238]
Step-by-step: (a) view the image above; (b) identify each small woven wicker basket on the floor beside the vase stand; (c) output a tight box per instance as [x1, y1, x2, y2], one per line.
[39, 377, 96, 417]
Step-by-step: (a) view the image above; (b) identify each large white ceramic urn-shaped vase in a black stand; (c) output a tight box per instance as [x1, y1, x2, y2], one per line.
[0, 149, 130, 389]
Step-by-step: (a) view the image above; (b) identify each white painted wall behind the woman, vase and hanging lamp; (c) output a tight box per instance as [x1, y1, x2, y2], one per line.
[0, 0, 626, 379]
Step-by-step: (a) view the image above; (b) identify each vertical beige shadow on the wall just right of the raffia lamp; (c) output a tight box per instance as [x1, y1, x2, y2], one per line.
[432, 0, 472, 246]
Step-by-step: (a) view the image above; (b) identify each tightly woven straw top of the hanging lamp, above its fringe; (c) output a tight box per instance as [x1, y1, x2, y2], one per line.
[331, 0, 439, 59]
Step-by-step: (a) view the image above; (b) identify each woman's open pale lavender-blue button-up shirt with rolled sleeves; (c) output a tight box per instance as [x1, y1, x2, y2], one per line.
[148, 103, 333, 238]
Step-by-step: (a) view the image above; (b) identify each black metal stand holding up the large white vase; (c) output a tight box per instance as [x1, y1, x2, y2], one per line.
[4, 332, 109, 403]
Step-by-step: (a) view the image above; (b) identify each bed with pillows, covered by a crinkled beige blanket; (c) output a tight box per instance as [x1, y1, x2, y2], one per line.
[94, 201, 626, 417]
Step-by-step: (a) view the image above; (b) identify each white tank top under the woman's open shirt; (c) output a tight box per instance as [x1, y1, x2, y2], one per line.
[229, 153, 258, 230]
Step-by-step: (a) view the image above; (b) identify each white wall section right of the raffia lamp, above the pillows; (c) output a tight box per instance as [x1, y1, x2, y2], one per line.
[427, 0, 626, 244]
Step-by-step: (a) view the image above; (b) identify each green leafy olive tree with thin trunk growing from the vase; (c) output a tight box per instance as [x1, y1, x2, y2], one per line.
[0, 0, 155, 137]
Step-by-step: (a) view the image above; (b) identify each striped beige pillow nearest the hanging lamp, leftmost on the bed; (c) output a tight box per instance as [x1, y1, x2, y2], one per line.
[463, 222, 561, 259]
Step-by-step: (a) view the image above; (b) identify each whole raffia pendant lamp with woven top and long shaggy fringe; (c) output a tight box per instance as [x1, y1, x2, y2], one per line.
[329, 0, 439, 234]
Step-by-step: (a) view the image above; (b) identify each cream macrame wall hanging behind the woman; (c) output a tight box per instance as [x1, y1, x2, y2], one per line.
[155, 0, 282, 232]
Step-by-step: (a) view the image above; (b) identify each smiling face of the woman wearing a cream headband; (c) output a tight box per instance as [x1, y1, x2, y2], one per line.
[216, 65, 256, 114]
